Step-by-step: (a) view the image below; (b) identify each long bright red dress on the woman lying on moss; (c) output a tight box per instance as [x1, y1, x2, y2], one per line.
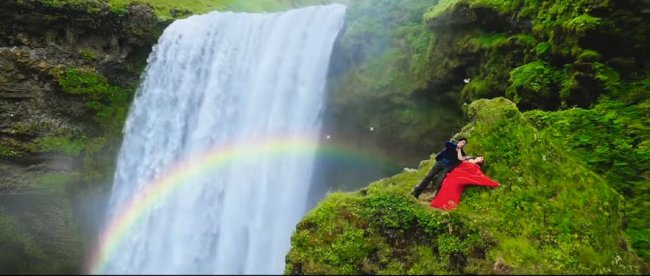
[431, 161, 499, 210]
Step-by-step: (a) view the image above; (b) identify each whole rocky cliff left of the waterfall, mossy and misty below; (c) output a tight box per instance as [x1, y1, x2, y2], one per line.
[0, 0, 161, 273]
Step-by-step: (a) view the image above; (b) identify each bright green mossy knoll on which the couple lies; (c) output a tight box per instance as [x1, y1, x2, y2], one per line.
[285, 98, 647, 274]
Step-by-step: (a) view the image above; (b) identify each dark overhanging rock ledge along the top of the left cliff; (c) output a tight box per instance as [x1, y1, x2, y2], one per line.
[0, 1, 157, 49]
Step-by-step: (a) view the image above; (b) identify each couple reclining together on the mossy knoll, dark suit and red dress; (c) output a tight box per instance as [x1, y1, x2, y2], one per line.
[412, 138, 499, 210]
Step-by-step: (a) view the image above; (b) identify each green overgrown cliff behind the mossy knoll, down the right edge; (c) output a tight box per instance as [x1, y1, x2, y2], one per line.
[412, 0, 650, 262]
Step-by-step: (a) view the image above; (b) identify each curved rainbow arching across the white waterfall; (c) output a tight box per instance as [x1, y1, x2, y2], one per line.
[85, 136, 395, 274]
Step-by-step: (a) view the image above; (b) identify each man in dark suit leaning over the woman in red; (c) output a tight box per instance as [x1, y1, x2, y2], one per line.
[411, 138, 468, 198]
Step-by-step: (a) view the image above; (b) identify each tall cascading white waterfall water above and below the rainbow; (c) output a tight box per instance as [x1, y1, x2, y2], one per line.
[100, 4, 345, 274]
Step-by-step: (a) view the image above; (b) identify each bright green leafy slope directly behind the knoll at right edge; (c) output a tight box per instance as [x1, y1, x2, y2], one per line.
[526, 97, 650, 259]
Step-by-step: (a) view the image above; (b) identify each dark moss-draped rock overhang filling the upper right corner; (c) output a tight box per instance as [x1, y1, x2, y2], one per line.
[424, 0, 650, 110]
